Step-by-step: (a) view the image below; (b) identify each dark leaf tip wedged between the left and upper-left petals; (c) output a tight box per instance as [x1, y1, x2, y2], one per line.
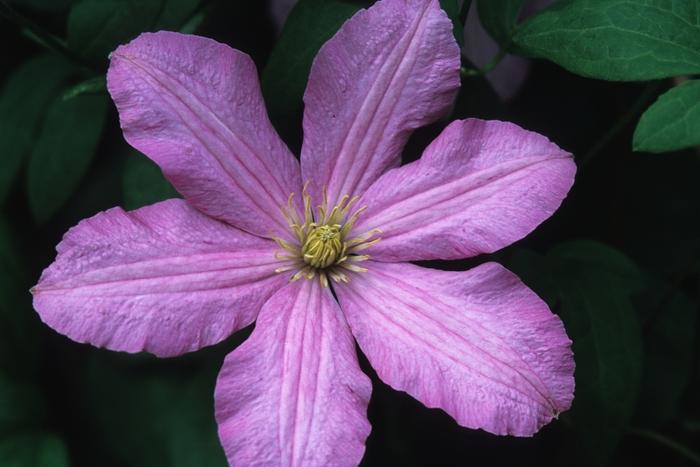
[122, 149, 180, 209]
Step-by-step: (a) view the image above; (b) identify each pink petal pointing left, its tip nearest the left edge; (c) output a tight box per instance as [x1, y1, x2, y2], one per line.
[32, 200, 286, 357]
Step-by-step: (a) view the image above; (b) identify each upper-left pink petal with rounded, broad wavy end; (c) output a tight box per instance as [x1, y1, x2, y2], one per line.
[107, 31, 301, 236]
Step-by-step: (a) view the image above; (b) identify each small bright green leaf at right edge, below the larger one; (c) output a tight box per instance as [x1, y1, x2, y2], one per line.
[633, 80, 700, 152]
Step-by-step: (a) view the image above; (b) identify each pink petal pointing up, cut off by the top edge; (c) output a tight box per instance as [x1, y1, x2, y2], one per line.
[301, 0, 460, 205]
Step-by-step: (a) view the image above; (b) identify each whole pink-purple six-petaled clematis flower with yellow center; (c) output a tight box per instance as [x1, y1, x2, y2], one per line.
[33, 0, 575, 466]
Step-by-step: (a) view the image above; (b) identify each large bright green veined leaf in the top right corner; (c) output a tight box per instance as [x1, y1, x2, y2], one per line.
[513, 0, 700, 81]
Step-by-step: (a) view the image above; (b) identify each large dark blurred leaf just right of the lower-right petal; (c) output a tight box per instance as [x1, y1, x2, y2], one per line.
[511, 241, 643, 465]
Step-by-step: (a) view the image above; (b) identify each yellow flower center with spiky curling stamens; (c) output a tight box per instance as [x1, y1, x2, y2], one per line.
[274, 185, 380, 287]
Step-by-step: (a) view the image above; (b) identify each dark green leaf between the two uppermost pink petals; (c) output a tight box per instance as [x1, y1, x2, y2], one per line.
[262, 0, 360, 141]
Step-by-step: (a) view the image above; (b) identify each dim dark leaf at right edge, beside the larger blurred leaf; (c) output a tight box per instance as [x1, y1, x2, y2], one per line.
[637, 279, 697, 425]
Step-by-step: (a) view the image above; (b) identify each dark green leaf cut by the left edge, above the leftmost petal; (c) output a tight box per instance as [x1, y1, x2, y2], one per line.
[0, 56, 71, 204]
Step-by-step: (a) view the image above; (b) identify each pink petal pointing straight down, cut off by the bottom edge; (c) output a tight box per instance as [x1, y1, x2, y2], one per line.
[215, 279, 371, 467]
